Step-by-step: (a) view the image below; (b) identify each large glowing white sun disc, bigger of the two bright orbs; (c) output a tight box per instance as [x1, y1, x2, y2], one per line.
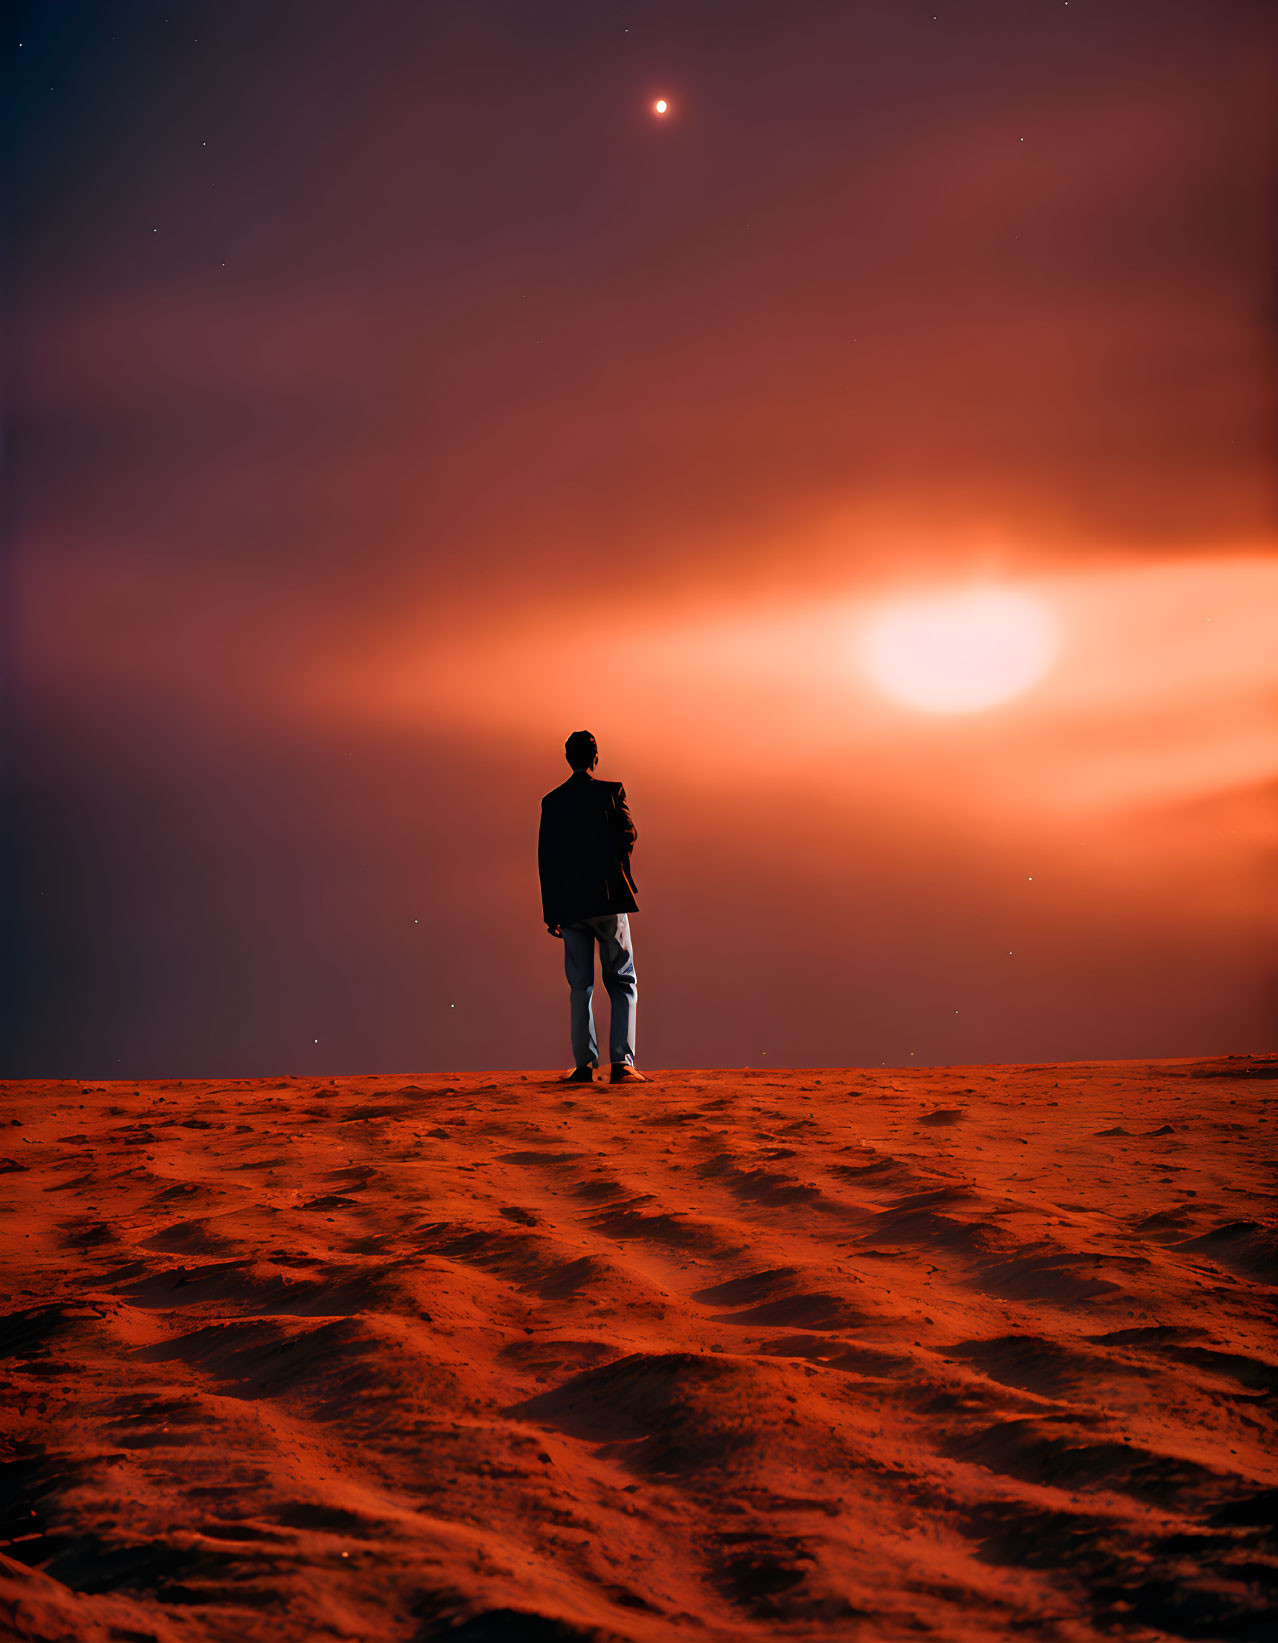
[861, 588, 1060, 713]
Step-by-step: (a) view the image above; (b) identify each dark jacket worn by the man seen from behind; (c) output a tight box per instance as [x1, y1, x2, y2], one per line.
[537, 771, 639, 925]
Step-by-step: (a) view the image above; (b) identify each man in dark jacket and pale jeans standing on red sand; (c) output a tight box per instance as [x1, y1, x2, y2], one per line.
[537, 729, 644, 1084]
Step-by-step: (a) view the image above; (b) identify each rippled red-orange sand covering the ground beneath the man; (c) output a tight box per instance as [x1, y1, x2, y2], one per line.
[0, 1060, 1278, 1643]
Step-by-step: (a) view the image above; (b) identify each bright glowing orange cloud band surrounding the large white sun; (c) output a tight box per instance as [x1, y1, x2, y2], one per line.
[299, 552, 1278, 823]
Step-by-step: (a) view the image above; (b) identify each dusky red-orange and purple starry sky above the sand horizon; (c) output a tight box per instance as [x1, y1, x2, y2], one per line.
[0, 0, 1278, 1078]
